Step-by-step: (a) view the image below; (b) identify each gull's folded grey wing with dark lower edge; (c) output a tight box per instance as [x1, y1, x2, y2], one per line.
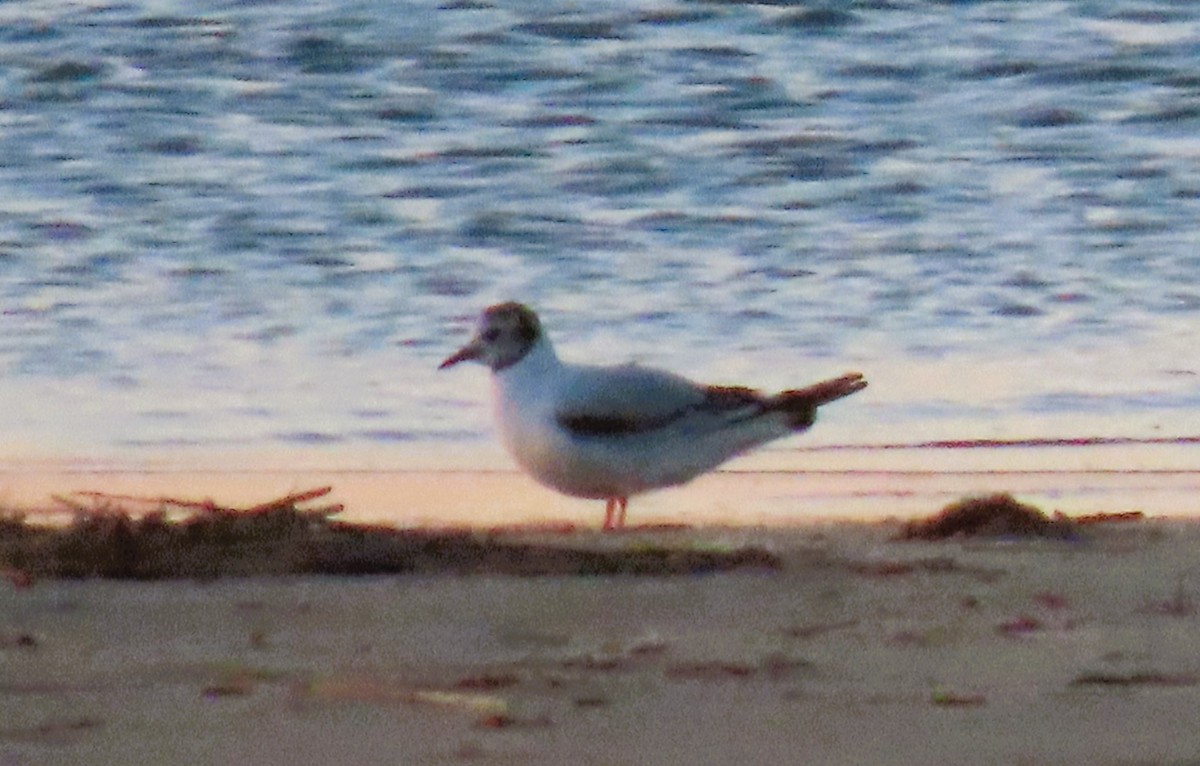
[556, 365, 766, 437]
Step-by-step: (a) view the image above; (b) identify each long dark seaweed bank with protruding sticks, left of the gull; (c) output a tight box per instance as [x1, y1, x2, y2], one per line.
[0, 490, 781, 581]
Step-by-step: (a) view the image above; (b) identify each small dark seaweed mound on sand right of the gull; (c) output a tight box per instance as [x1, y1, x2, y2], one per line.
[898, 493, 1078, 540]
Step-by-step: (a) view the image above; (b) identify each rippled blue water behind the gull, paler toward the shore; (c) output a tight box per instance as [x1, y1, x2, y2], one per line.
[0, 0, 1200, 516]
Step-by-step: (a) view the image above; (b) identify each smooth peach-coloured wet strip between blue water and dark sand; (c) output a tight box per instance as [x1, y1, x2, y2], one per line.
[0, 456, 1200, 528]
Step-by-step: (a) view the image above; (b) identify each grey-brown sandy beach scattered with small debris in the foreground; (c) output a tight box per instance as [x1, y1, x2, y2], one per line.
[0, 504, 1200, 766]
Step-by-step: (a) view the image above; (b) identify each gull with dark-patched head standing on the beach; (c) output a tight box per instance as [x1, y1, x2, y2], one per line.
[438, 303, 866, 531]
